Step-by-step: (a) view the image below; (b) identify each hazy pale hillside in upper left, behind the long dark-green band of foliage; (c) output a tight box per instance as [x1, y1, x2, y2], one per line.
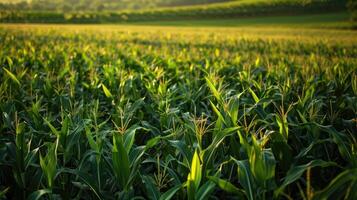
[0, 0, 232, 12]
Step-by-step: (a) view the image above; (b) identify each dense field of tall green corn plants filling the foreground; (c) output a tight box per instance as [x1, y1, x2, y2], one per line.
[0, 26, 357, 200]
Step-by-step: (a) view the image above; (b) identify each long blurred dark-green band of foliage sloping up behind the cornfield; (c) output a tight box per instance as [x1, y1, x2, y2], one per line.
[0, 0, 346, 23]
